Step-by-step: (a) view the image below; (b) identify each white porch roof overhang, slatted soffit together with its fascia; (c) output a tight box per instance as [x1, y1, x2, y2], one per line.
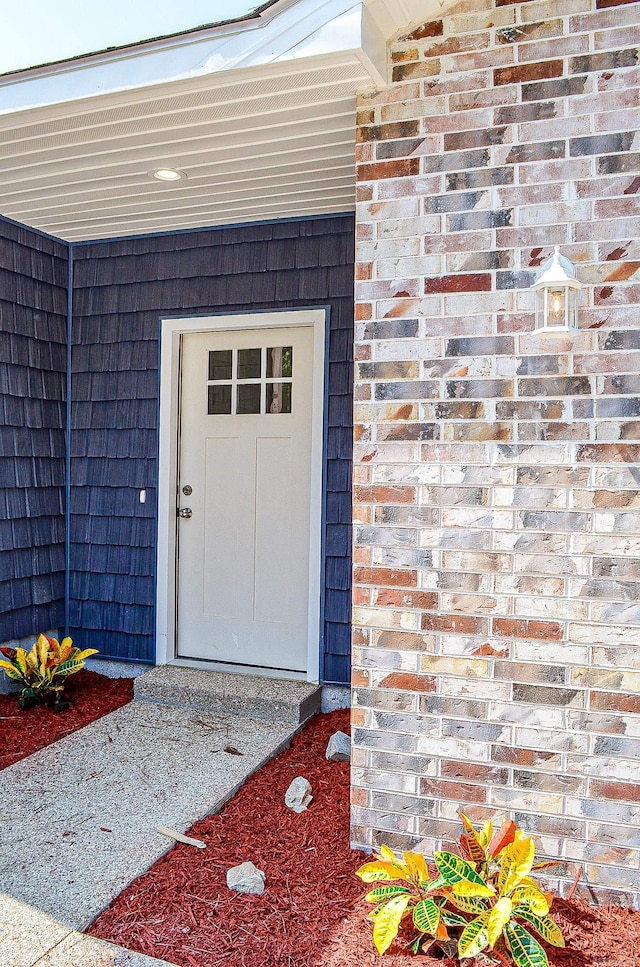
[0, 0, 437, 241]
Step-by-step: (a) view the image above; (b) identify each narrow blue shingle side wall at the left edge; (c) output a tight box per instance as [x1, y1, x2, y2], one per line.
[0, 219, 68, 642]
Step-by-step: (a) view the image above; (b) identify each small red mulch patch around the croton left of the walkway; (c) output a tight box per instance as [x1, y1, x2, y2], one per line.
[0, 669, 133, 769]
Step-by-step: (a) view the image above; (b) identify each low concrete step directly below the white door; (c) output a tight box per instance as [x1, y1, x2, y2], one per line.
[134, 665, 322, 726]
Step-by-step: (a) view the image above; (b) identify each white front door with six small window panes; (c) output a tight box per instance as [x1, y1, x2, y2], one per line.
[176, 327, 313, 672]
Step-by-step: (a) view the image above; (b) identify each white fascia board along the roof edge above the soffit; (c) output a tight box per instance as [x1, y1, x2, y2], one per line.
[0, 0, 384, 116]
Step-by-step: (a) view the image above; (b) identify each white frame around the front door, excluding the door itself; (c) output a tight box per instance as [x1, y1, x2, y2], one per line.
[156, 307, 329, 682]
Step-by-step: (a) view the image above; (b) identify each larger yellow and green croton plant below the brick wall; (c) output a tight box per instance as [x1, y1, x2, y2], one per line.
[358, 813, 564, 967]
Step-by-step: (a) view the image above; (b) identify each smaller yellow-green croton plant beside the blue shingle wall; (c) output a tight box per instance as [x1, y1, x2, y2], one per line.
[0, 635, 97, 709]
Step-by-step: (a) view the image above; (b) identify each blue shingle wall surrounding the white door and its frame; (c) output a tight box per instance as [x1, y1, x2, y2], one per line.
[70, 216, 354, 683]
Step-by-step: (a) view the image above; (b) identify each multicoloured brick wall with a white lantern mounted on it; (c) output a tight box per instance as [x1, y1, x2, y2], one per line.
[352, 0, 640, 903]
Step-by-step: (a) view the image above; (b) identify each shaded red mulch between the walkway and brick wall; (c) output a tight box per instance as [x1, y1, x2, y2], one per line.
[90, 711, 363, 967]
